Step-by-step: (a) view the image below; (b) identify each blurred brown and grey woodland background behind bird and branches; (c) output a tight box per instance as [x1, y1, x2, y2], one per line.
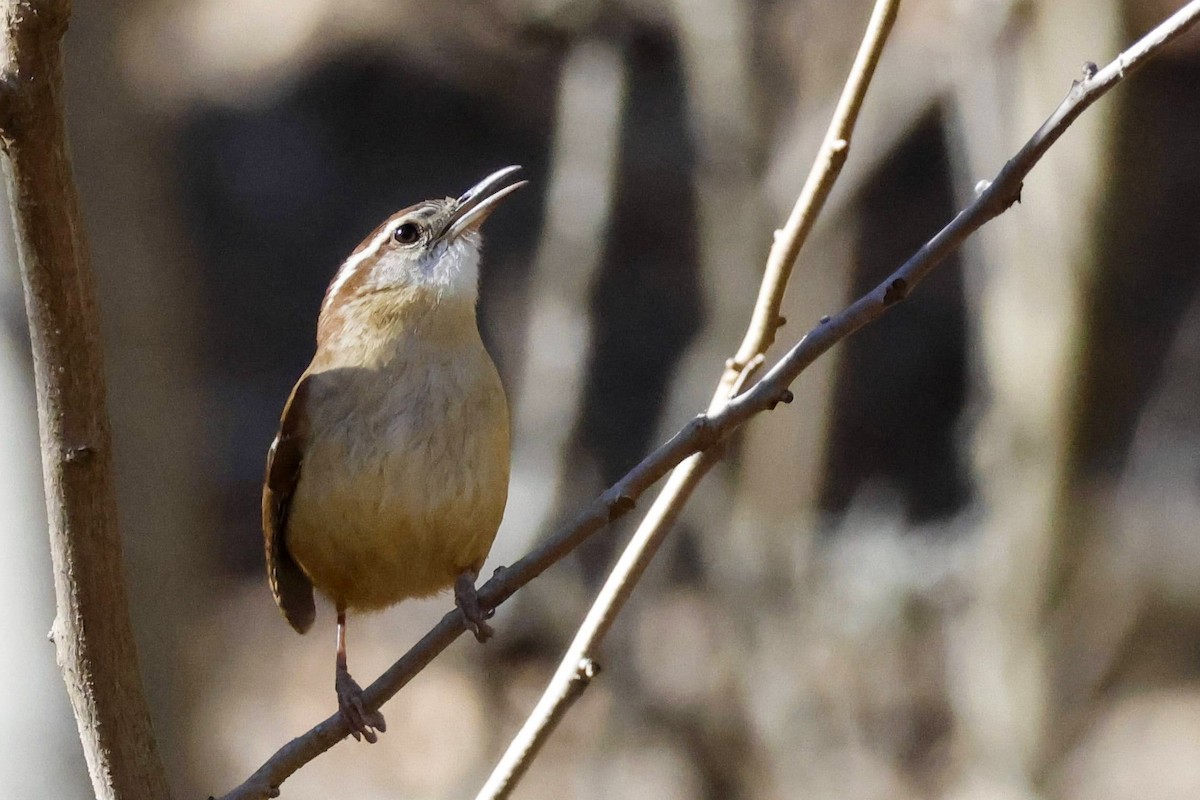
[0, 0, 1200, 800]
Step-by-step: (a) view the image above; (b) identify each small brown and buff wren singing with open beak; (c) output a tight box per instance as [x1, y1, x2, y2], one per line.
[263, 167, 524, 742]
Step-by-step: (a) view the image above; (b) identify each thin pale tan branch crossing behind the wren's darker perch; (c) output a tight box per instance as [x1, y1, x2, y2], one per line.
[475, 0, 900, 800]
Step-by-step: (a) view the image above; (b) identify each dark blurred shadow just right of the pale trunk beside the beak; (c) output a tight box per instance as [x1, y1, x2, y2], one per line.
[573, 28, 700, 579]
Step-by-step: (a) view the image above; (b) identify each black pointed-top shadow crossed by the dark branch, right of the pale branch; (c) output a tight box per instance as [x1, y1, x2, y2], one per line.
[820, 114, 972, 524]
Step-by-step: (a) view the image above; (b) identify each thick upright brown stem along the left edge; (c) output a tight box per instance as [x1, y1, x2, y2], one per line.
[0, 0, 170, 800]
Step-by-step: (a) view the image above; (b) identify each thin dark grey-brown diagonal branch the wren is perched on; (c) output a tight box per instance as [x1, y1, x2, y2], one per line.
[216, 0, 1200, 800]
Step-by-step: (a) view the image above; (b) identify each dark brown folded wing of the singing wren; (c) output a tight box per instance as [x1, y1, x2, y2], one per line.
[263, 375, 317, 633]
